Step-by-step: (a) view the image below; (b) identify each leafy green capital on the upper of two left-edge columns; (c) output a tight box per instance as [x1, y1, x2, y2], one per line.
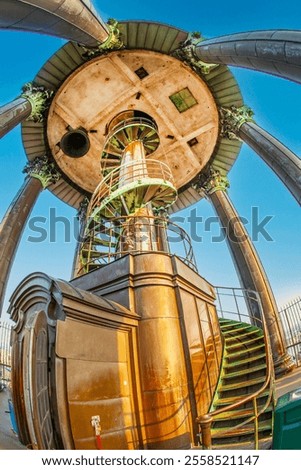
[21, 82, 53, 122]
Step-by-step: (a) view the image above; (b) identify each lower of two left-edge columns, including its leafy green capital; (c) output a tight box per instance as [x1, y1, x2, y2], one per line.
[0, 157, 60, 316]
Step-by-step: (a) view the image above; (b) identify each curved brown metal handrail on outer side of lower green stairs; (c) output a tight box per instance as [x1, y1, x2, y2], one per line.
[197, 289, 274, 449]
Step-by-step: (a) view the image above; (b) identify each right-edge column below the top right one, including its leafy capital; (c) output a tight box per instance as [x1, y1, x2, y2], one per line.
[220, 106, 301, 204]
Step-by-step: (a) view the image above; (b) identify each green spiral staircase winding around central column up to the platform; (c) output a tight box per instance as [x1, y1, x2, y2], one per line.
[80, 111, 177, 273]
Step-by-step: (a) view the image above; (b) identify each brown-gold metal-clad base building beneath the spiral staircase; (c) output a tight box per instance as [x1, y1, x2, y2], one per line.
[10, 262, 222, 449]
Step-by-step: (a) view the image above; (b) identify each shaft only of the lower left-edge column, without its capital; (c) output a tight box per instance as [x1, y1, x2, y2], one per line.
[0, 178, 42, 315]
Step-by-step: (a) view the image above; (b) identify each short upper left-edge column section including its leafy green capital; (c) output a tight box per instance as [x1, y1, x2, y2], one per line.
[0, 83, 53, 138]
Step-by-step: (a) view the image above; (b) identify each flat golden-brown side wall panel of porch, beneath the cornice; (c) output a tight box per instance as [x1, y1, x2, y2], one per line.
[56, 319, 140, 449]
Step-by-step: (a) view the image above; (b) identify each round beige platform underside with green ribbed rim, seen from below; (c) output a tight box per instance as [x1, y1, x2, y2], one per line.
[22, 22, 243, 211]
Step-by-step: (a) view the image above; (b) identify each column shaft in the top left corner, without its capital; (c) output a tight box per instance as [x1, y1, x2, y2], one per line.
[0, 0, 109, 46]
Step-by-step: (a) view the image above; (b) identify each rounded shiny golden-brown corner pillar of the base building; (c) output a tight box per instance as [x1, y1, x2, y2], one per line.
[132, 253, 193, 450]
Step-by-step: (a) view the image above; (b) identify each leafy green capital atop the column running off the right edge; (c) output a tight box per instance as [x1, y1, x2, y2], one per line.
[219, 105, 254, 140]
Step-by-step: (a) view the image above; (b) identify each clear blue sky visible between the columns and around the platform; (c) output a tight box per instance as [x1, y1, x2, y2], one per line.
[0, 0, 301, 318]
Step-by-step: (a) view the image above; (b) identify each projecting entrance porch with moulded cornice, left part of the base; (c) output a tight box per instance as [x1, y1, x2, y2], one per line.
[10, 273, 141, 449]
